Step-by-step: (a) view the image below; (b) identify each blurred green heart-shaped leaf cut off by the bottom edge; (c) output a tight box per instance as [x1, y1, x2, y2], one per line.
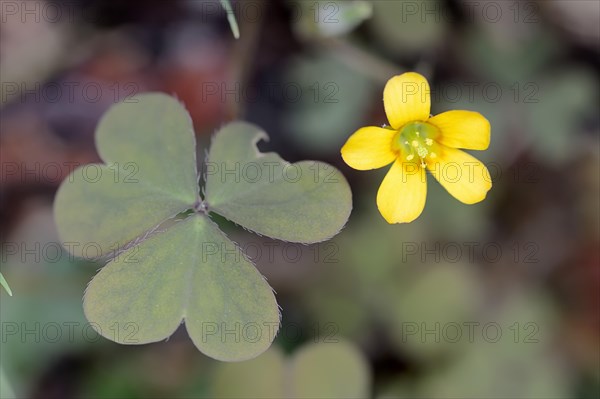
[212, 341, 371, 399]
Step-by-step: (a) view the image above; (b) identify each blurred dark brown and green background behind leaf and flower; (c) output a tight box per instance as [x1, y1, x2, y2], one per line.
[0, 0, 600, 398]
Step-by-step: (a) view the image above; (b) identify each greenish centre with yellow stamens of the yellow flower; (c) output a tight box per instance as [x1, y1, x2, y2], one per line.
[392, 122, 440, 168]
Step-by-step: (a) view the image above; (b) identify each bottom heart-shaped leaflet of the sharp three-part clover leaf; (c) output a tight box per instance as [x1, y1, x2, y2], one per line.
[84, 214, 279, 361]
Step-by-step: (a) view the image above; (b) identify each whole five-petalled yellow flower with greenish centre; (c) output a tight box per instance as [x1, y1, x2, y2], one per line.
[341, 72, 492, 223]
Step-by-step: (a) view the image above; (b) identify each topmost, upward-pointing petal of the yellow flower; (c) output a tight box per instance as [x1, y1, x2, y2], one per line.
[383, 72, 431, 129]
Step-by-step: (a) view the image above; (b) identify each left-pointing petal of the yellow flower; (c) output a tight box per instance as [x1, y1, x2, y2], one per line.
[342, 126, 396, 170]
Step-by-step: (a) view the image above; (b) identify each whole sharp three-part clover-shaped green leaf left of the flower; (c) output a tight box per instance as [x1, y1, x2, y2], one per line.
[55, 93, 351, 361]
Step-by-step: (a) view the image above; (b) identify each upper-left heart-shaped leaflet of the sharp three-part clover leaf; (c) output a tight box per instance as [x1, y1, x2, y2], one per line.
[54, 93, 199, 258]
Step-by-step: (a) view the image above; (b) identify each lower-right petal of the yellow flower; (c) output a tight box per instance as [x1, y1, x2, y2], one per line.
[427, 145, 492, 204]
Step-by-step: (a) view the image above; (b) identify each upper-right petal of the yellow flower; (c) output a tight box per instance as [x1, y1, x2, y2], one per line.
[427, 111, 491, 150]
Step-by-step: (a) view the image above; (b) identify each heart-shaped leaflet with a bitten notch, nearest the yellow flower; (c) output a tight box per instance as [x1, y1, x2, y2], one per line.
[206, 122, 352, 243]
